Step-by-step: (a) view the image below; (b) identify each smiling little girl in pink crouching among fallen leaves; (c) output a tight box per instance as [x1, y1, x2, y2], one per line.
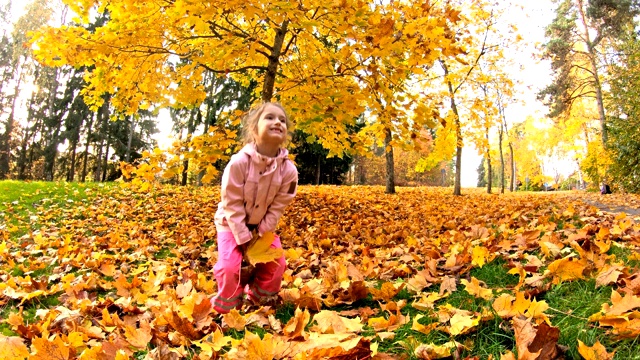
[211, 102, 298, 314]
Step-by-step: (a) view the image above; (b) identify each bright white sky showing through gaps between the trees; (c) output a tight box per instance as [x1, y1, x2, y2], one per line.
[7, 0, 555, 187]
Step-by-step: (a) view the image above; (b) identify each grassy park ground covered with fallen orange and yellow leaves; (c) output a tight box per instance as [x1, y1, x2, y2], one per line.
[0, 183, 640, 359]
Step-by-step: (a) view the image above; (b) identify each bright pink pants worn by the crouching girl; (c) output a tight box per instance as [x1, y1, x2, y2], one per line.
[211, 231, 287, 314]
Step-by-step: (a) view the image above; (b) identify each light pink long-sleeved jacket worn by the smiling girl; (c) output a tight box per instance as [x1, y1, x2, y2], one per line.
[215, 144, 298, 245]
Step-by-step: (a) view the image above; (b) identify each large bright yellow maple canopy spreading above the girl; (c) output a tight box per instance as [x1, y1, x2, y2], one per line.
[34, 0, 459, 191]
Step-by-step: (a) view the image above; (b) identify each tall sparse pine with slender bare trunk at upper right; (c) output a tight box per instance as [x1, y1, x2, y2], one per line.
[538, 0, 640, 143]
